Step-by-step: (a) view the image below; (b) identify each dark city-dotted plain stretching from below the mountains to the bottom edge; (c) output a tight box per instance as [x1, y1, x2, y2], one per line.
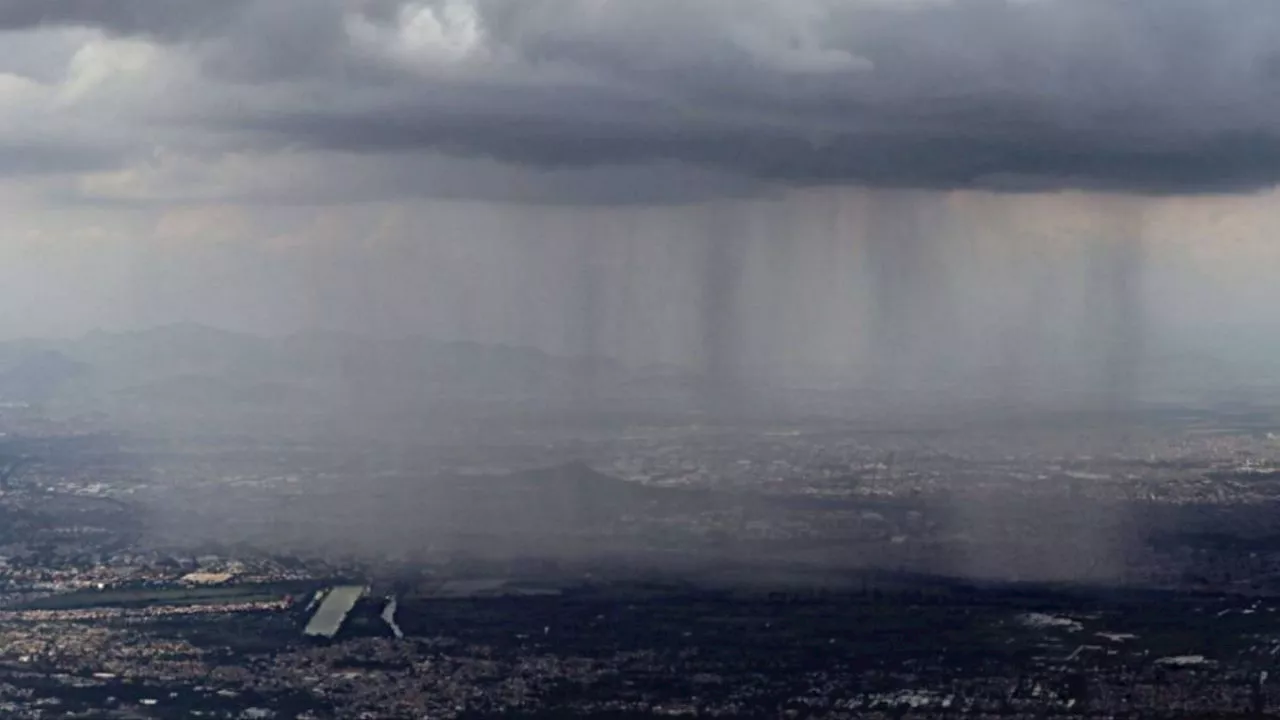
[0, 394, 1280, 717]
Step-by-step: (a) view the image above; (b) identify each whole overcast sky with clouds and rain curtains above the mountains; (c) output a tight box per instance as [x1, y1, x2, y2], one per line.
[0, 0, 1280, 386]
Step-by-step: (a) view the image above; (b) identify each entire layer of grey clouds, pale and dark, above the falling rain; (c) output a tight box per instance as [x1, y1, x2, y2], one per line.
[0, 0, 1280, 202]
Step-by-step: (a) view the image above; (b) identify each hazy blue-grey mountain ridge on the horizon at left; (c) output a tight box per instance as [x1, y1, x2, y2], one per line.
[0, 324, 701, 415]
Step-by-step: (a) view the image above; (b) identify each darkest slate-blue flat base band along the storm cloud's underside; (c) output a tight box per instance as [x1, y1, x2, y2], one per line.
[247, 113, 1280, 192]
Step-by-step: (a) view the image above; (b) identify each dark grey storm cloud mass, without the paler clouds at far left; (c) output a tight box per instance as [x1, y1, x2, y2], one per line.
[20, 0, 1280, 192]
